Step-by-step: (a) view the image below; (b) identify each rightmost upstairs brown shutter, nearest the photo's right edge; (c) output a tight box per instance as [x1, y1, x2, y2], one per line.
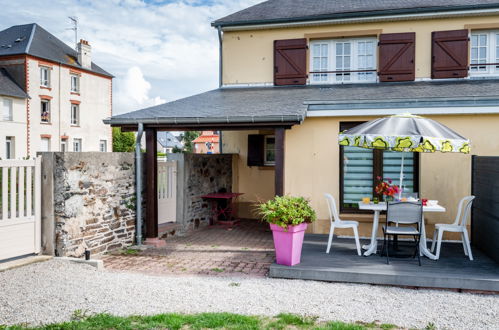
[431, 30, 469, 79]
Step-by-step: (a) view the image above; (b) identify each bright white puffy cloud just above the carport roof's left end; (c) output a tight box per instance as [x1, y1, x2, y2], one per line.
[114, 66, 166, 112]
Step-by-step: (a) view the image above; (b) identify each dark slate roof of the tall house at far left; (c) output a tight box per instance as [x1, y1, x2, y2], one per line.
[0, 23, 112, 77]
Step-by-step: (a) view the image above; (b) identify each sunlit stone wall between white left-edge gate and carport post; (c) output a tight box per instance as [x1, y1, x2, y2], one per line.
[42, 152, 135, 257]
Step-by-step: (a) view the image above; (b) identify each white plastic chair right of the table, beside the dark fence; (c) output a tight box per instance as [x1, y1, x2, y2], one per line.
[431, 196, 475, 260]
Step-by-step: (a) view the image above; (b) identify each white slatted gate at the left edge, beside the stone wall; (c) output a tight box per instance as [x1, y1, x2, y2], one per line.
[0, 157, 41, 261]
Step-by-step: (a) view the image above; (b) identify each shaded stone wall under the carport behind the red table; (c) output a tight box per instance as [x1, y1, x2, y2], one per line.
[169, 154, 233, 232]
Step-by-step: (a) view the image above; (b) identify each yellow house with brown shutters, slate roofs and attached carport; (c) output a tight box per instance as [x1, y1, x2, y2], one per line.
[105, 0, 499, 242]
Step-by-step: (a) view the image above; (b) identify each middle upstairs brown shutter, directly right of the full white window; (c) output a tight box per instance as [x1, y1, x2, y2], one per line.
[378, 32, 416, 81]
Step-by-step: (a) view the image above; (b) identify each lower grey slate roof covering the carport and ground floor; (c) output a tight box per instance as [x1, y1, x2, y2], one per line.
[104, 79, 499, 126]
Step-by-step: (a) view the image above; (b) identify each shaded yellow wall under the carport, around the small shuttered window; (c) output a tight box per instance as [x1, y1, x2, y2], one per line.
[222, 131, 274, 219]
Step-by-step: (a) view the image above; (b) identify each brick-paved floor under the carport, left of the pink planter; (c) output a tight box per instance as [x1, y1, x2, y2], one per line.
[102, 220, 275, 277]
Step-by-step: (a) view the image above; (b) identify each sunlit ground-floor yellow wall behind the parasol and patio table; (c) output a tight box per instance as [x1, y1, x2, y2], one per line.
[285, 115, 499, 238]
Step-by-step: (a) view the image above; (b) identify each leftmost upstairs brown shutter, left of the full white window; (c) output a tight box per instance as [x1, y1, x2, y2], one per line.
[274, 39, 307, 86]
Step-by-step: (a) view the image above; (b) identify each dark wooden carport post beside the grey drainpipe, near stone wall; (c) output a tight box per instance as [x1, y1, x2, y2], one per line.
[144, 127, 166, 247]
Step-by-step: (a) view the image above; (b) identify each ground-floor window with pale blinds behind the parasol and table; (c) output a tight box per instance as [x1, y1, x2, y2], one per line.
[340, 123, 419, 212]
